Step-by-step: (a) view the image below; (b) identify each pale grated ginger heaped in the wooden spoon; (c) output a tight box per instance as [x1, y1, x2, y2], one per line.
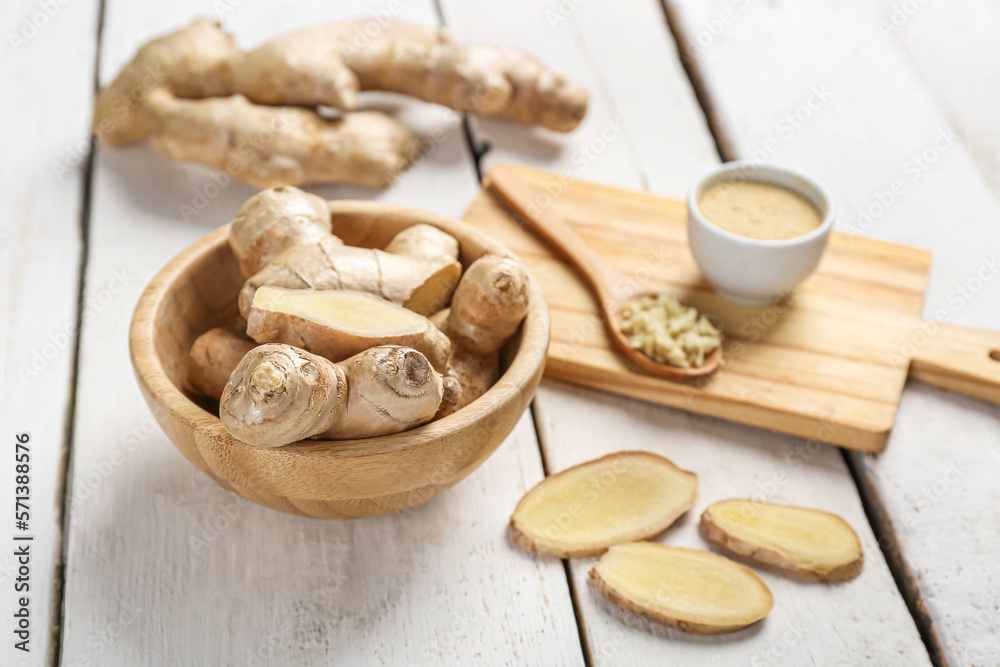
[618, 294, 722, 368]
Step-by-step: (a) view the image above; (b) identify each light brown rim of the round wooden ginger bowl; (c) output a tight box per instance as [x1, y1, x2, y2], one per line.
[129, 200, 550, 457]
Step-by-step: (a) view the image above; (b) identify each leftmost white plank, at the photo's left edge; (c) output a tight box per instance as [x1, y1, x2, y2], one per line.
[0, 0, 100, 666]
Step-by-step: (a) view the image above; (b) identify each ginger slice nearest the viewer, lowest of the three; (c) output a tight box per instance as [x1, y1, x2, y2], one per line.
[590, 542, 774, 635]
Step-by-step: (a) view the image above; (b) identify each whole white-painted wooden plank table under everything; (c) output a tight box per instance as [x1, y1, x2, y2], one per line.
[0, 0, 1000, 667]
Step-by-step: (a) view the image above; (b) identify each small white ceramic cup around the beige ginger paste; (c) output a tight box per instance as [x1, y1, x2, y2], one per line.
[688, 161, 834, 306]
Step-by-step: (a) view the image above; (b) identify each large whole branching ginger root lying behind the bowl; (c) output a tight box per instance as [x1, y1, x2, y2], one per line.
[93, 18, 588, 187]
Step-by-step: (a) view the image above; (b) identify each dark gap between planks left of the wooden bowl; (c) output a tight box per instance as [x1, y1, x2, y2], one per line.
[49, 0, 106, 667]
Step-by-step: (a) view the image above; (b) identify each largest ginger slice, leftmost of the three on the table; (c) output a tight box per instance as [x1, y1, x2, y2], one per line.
[510, 451, 698, 558]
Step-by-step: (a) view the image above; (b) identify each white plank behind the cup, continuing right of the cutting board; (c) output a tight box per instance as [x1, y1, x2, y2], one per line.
[668, 0, 1000, 665]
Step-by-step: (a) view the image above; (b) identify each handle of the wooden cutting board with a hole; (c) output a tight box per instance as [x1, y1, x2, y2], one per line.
[910, 322, 1000, 403]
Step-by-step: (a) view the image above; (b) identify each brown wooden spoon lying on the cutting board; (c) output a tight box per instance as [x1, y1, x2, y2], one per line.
[486, 167, 722, 380]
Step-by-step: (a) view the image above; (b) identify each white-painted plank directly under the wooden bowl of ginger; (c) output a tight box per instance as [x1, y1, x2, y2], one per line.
[56, 0, 582, 667]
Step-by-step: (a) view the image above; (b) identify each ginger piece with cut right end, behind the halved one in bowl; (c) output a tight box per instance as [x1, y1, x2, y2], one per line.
[239, 236, 462, 319]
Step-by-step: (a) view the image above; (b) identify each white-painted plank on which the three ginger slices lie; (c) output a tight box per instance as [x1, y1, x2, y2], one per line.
[442, 0, 928, 665]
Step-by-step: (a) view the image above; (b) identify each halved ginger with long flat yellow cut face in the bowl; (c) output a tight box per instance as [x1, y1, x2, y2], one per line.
[247, 287, 451, 371]
